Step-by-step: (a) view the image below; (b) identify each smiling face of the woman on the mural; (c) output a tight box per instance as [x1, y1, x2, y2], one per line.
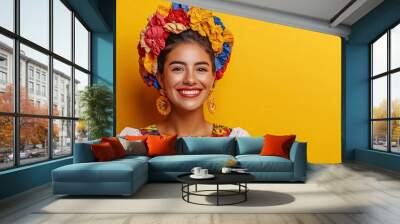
[161, 43, 215, 111]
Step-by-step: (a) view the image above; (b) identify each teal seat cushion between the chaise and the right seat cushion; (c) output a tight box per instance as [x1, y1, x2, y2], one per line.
[149, 154, 235, 172]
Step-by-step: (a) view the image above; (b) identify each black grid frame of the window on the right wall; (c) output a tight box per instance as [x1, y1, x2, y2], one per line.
[368, 21, 400, 155]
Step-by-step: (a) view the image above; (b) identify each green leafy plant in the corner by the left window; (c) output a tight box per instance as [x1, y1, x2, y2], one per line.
[79, 84, 113, 140]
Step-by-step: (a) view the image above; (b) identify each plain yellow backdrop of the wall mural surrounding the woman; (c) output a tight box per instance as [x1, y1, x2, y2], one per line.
[116, 0, 341, 163]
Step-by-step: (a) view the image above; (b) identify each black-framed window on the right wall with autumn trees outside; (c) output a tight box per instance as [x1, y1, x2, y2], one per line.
[370, 24, 400, 153]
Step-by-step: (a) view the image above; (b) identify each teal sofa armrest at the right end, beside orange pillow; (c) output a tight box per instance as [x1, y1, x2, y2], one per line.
[290, 142, 307, 181]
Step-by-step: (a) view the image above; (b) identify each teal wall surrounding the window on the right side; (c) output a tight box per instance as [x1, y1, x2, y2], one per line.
[342, 0, 400, 170]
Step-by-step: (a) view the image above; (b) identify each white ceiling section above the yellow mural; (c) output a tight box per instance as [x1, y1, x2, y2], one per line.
[175, 0, 383, 38]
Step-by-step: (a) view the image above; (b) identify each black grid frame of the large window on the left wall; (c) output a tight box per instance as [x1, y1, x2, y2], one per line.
[0, 0, 93, 172]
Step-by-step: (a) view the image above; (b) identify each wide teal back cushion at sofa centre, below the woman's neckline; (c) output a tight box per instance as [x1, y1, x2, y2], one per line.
[177, 137, 235, 155]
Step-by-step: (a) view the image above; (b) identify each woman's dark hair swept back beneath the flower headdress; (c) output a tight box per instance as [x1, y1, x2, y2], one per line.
[157, 29, 215, 74]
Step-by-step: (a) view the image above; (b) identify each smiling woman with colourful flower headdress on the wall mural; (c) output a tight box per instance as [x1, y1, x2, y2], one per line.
[120, 3, 249, 137]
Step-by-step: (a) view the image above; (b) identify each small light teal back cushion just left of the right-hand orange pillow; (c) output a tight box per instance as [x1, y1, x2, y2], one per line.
[236, 137, 264, 155]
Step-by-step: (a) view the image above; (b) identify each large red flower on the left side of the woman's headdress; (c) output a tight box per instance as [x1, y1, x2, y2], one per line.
[144, 26, 168, 57]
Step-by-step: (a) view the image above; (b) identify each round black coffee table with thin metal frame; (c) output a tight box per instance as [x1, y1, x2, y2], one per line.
[177, 173, 255, 206]
